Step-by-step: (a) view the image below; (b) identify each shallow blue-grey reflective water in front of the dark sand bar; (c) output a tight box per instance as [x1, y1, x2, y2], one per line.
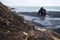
[21, 15, 60, 29]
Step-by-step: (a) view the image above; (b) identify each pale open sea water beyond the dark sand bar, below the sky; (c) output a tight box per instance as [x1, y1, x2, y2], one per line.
[10, 6, 60, 12]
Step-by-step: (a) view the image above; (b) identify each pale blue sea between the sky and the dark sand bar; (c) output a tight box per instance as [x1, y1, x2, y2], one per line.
[11, 6, 60, 12]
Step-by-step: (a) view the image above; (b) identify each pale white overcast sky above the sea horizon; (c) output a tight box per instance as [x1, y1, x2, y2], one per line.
[0, 0, 60, 6]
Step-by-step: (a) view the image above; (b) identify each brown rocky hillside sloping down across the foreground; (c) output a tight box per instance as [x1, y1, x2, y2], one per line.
[0, 2, 60, 40]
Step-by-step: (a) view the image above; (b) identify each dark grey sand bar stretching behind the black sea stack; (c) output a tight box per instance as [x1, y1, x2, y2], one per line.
[17, 11, 60, 18]
